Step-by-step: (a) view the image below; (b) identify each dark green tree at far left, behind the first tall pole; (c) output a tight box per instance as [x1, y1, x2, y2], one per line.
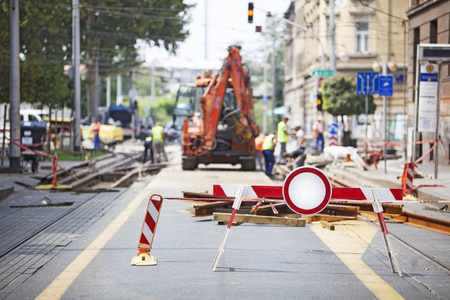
[0, 0, 71, 107]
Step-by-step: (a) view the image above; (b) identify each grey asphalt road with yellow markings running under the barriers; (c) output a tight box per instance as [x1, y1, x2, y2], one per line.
[0, 151, 450, 299]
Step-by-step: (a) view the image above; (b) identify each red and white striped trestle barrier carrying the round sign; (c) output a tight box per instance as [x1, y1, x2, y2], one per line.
[213, 167, 403, 277]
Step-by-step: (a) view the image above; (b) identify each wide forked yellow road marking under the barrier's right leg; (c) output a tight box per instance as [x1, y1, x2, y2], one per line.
[312, 221, 404, 299]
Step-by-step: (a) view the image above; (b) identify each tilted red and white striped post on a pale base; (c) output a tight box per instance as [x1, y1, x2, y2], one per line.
[131, 194, 163, 266]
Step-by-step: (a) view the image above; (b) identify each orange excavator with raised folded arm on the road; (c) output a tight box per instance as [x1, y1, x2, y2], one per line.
[174, 46, 259, 171]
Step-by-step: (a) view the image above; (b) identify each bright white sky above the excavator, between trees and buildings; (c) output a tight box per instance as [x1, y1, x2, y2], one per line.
[145, 0, 291, 62]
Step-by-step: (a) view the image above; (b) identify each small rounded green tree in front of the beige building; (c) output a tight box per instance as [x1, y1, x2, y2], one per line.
[322, 76, 376, 116]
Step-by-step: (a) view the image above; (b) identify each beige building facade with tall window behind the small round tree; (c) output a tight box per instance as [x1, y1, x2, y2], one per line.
[285, 0, 409, 145]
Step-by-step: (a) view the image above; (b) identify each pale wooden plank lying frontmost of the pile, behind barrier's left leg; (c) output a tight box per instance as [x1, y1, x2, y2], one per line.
[213, 212, 306, 227]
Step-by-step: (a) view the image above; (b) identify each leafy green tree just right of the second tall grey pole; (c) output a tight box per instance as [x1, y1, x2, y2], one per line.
[86, 0, 191, 119]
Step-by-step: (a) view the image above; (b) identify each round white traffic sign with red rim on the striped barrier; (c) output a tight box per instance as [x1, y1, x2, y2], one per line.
[283, 167, 332, 215]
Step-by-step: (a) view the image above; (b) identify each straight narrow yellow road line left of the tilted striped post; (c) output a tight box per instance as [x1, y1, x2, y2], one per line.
[36, 191, 148, 300]
